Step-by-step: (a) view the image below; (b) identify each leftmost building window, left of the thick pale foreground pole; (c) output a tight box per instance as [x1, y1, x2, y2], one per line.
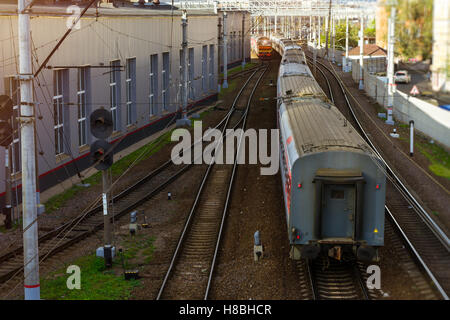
[5, 77, 21, 174]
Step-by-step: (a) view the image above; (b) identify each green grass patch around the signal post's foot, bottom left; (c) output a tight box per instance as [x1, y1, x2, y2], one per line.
[41, 255, 141, 300]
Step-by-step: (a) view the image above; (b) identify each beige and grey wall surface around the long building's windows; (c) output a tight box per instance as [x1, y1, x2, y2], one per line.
[0, 9, 227, 193]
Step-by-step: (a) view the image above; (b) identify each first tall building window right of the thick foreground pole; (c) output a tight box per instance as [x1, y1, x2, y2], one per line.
[53, 70, 68, 155]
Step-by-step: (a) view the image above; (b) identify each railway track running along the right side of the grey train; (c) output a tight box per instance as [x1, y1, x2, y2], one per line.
[307, 52, 450, 300]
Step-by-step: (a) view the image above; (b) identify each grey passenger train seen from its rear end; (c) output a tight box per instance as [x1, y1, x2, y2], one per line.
[273, 40, 386, 261]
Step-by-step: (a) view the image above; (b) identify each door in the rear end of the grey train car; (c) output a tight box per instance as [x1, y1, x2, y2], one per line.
[321, 184, 356, 239]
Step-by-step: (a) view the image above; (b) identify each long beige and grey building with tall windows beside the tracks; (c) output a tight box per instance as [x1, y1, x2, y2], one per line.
[0, 1, 250, 211]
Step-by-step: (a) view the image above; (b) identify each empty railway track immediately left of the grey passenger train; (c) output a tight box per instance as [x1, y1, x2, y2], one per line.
[156, 68, 267, 300]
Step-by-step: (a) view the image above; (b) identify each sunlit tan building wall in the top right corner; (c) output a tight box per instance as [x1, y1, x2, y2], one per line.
[431, 0, 450, 92]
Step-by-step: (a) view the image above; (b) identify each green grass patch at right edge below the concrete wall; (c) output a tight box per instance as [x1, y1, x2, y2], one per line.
[415, 142, 450, 179]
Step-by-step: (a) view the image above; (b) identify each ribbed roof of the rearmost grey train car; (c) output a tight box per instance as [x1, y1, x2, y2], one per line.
[281, 98, 370, 157]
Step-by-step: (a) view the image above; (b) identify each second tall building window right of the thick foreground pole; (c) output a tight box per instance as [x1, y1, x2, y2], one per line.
[77, 67, 89, 147]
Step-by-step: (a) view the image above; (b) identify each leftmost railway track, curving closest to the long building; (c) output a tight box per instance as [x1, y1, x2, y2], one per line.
[0, 68, 268, 296]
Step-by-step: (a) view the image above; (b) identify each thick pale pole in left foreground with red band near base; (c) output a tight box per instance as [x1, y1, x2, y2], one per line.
[18, 0, 41, 300]
